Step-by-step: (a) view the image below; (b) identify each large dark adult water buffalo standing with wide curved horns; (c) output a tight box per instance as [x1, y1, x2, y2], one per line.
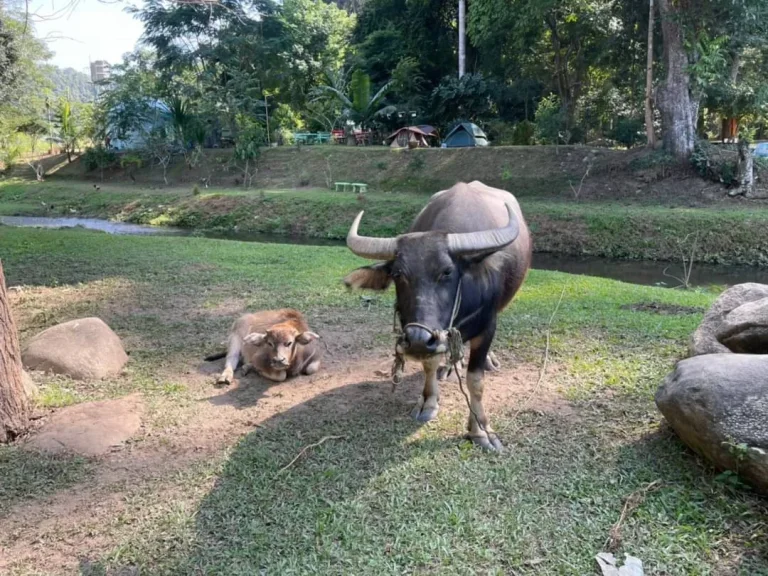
[344, 181, 531, 450]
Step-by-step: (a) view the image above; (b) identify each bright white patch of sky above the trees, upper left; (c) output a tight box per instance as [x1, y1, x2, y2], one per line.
[30, 0, 142, 72]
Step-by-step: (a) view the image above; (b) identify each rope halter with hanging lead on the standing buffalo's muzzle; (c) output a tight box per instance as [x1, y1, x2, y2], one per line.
[392, 280, 488, 434]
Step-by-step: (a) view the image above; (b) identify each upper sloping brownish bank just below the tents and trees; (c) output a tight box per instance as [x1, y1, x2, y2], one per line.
[56, 146, 760, 206]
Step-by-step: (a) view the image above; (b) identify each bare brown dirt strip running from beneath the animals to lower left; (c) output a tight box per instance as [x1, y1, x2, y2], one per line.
[0, 340, 570, 572]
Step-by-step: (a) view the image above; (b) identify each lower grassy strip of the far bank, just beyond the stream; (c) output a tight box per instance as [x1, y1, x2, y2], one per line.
[0, 180, 768, 266]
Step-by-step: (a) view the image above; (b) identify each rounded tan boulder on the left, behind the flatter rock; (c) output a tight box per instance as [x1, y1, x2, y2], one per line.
[21, 318, 128, 380]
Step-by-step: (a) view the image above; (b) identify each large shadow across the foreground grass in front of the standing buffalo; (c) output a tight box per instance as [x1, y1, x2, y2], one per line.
[82, 381, 768, 576]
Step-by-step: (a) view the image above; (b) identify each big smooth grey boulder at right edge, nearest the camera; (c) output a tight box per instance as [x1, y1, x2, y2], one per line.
[656, 354, 768, 494]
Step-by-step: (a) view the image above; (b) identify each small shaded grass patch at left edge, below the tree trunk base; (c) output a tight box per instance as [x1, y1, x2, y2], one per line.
[0, 446, 92, 518]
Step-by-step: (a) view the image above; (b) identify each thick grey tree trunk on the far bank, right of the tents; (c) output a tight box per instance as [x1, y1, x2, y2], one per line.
[657, 0, 699, 162]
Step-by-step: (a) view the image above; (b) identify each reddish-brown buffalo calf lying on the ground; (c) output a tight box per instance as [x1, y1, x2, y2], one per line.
[206, 308, 320, 384]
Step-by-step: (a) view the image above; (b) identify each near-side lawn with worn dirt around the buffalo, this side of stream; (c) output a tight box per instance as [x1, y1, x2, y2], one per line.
[0, 226, 768, 575]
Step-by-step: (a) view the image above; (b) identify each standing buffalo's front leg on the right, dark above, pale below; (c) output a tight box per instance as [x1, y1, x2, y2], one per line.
[467, 327, 503, 451]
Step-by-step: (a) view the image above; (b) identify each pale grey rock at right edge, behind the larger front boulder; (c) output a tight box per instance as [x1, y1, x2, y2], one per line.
[689, 282, 768, 356]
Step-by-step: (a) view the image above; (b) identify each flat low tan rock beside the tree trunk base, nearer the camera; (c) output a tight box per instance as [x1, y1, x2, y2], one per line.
[27, 394, 144, 456]
